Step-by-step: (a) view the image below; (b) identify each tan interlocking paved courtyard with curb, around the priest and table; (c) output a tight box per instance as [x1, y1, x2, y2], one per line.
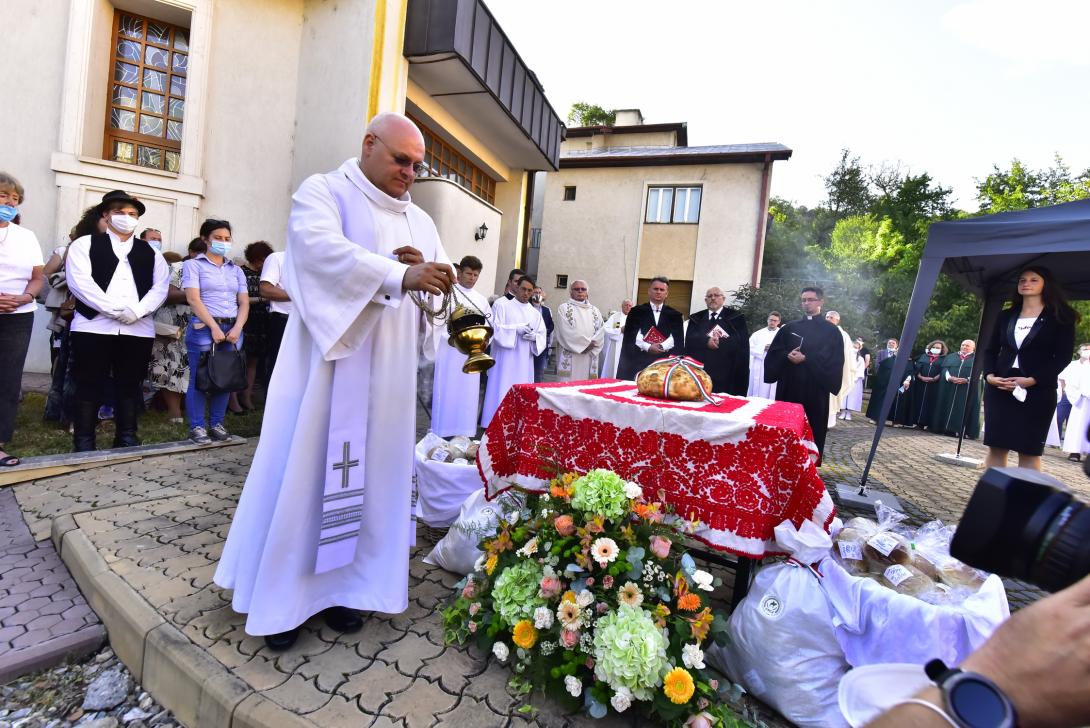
[6, 398, 1086, 728]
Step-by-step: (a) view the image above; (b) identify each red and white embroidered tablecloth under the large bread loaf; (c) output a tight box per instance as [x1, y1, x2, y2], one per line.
[477, 379, 835, 558]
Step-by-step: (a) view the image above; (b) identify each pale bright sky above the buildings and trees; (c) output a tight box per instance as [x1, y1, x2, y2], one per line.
[485, 0, 1090, 210]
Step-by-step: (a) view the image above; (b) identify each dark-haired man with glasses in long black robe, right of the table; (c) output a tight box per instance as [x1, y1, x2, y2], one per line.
[764, 289, 844, 464]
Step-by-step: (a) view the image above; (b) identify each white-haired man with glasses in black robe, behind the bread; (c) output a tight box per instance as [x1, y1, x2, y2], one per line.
[685, 288, 749, 397]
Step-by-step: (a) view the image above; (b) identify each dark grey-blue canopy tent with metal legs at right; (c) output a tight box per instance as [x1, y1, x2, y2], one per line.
[860, 199, 1090, 494]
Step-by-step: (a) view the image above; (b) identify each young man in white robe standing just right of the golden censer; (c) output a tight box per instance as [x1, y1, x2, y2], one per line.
[481, 276, 545, 427]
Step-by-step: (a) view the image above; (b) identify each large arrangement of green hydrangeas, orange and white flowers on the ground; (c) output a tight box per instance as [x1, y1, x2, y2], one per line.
[443, 470, 740, 727]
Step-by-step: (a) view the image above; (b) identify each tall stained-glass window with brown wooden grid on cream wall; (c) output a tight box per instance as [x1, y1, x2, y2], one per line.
[102, 10, 190, 172]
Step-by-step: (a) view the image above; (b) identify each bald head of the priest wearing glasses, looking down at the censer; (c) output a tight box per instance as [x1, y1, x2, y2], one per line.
[360, 111, 424, 197]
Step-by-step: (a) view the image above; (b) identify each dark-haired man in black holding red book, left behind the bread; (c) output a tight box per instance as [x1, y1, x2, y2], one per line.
[617, 276, 685, 379]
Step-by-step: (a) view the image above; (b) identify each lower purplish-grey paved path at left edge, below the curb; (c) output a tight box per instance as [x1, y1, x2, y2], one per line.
[0, 489, 106, 683]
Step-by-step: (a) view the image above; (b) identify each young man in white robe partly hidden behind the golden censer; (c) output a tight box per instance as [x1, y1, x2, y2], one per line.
[432, 255, 489, 437]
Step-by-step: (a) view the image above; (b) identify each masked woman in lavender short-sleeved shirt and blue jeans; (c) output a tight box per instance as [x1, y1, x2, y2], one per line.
[182, 219, 250, 445]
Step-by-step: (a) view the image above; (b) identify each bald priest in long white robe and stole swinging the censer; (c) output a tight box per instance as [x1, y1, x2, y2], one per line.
[215, 113, 455, 650]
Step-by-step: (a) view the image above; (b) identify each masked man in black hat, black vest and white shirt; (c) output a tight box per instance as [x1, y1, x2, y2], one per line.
[65, 190, 170, 452]
